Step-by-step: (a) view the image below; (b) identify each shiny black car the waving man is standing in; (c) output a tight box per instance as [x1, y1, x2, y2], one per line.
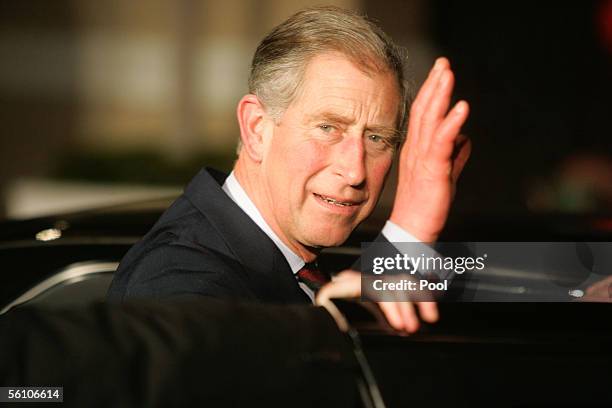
[0, 202, 612, 407]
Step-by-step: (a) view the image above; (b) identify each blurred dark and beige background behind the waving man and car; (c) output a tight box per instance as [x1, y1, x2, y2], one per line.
[0, 0, 612, 218]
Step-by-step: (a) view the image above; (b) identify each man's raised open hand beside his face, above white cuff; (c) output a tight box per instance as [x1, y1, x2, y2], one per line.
[390, 58, 471, 242]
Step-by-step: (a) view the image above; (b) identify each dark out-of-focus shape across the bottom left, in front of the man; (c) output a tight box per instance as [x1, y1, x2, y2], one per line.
[0, 299, 357, 407]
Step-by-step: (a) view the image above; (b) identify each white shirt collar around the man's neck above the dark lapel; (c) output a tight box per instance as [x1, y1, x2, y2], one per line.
[222, 171, 305, 274]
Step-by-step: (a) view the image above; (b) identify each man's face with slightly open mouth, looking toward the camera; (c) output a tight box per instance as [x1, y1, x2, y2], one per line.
[261, 53, 400, 253]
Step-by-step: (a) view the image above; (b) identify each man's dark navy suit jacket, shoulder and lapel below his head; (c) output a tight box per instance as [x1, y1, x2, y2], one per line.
[108, 169, 310, 304]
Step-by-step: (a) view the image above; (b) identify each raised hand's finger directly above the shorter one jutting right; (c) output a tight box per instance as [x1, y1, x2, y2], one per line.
[419, 69, 455, 154]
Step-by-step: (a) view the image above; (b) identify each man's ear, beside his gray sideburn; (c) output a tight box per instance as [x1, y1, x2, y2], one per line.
[236, 94, 267, 162]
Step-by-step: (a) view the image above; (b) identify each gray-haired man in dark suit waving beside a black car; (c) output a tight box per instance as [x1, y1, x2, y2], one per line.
[109, 7, 470, 332]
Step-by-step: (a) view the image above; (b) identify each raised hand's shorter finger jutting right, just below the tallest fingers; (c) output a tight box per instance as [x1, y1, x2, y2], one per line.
[427, 101, 469, 168]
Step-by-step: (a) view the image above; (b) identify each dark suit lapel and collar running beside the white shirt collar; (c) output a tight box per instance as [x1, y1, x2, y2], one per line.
[185, 168, 310, 303]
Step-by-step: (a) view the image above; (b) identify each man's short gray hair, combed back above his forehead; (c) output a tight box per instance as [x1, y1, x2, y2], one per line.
[249, 6, 408, 139]
